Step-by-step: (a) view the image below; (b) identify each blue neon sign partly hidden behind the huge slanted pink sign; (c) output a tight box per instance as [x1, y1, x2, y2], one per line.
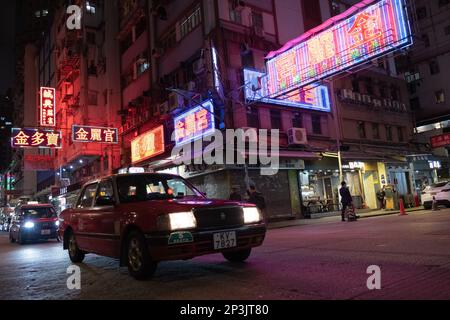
[244, 69, 331, 112]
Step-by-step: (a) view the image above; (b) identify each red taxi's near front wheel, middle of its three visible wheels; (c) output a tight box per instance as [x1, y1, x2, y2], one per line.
[126, 231, 158, 280]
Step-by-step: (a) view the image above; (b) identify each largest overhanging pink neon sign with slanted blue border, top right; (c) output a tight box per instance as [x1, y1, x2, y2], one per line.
[267, 0, 412, 98]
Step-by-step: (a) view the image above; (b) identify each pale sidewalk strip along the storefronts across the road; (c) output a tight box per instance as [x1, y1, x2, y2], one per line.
[268, 207, 425, 229]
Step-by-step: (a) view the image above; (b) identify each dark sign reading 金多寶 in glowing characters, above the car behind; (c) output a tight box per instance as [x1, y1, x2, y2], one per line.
[11, 128, 62, 149]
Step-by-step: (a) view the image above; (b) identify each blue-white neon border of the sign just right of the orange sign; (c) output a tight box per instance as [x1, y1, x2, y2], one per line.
[174, 100, 216, 146]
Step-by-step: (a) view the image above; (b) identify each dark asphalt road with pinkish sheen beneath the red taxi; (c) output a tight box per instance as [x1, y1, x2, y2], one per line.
[0, 210, 450, 300]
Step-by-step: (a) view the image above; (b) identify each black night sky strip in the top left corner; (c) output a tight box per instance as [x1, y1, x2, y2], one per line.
[0, 0, 15, 94]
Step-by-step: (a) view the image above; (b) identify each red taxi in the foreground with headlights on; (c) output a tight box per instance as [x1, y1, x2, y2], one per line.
[59, 173, 266, 279]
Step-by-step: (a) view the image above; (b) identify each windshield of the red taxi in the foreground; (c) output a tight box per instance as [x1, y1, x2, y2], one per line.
[117, 175, 202, 203]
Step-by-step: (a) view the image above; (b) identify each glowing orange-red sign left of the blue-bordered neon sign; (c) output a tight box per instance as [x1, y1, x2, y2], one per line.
[131, 126, 165, 163]
